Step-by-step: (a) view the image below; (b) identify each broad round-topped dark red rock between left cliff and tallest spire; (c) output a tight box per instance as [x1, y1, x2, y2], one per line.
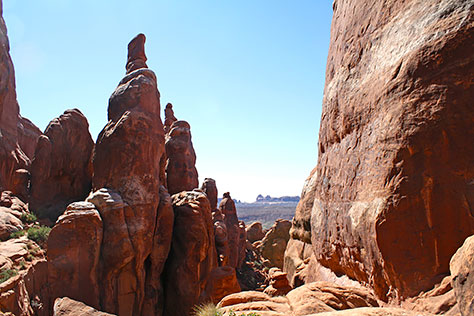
[30, 109, 94, 221]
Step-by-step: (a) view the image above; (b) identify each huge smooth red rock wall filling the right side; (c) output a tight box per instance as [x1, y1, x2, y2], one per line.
[304, 0, 474, 298]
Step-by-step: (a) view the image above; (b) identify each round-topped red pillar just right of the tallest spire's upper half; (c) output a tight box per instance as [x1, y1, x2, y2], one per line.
[165, 121, 199, 195]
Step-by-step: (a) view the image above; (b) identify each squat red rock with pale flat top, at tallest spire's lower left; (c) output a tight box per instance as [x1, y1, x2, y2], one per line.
[47, 202, 103, 308]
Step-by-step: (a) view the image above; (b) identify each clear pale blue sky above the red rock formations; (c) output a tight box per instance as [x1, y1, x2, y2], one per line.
[3, 0, 332, 201]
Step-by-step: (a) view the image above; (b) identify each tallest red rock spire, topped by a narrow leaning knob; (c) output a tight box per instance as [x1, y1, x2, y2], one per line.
[45, 35, 173, 316]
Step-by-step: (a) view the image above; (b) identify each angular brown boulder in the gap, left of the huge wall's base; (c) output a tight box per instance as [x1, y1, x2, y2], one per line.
[257, 219, 291, 269]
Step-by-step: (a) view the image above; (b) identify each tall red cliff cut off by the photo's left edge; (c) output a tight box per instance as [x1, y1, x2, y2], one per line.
[0, 1, 38, 191]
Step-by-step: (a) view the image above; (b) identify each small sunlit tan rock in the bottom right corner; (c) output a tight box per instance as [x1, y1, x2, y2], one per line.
[450, 236, 474, 316]
